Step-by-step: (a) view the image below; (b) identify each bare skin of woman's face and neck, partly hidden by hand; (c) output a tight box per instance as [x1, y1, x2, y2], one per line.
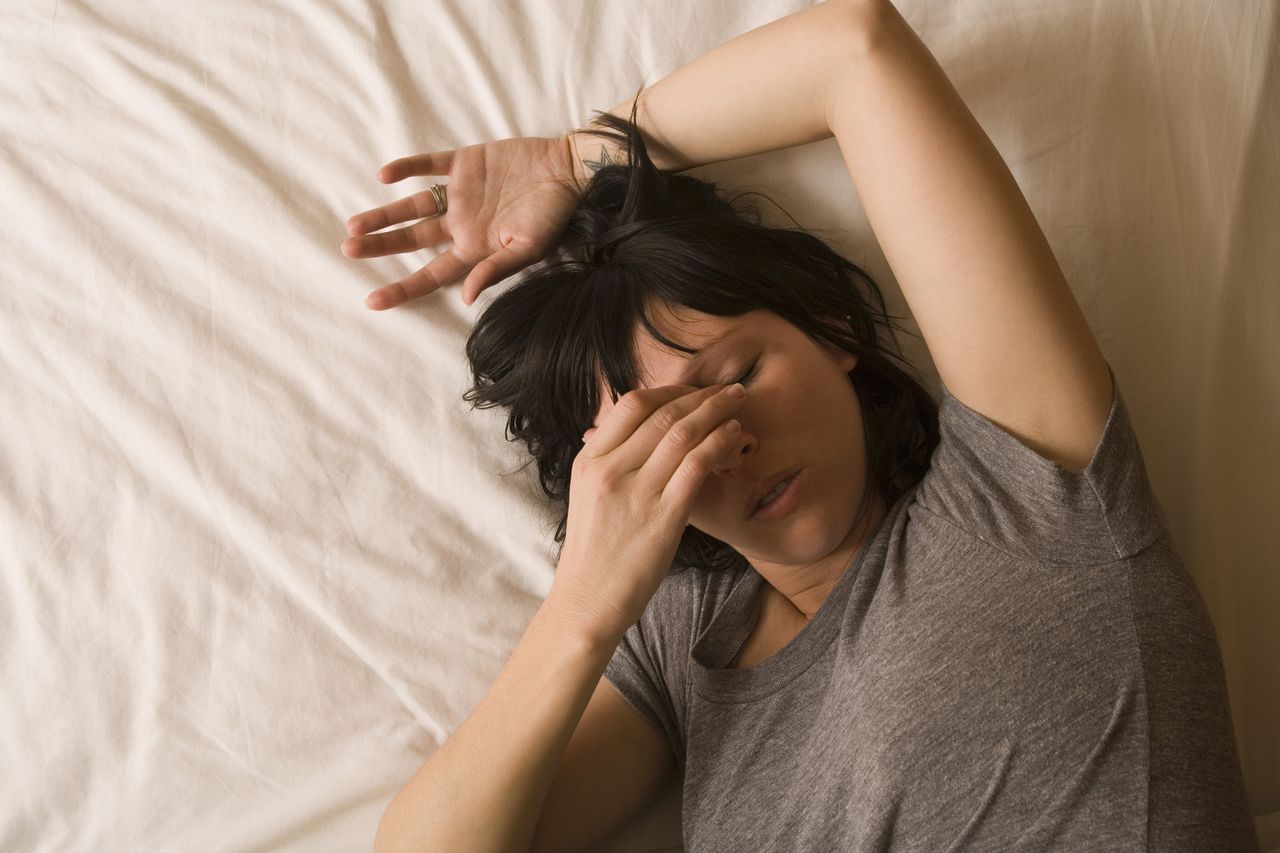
[595, 302, 886, 625]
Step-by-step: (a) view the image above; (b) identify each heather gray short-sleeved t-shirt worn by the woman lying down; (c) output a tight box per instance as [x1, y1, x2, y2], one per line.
[604, 373, 1258, 853]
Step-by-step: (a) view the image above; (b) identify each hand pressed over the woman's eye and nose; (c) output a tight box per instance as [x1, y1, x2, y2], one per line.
[548, 384, 745, 639]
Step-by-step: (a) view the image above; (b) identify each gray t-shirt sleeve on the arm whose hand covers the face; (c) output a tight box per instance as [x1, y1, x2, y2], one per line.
[604, 570, 698, 771]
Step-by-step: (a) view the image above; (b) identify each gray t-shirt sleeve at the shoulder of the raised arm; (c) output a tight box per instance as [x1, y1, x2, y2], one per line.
[915, 364, 1167, 565]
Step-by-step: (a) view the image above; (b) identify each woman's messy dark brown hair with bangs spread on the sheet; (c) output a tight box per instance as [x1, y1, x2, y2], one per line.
[463, 97, 938, 573]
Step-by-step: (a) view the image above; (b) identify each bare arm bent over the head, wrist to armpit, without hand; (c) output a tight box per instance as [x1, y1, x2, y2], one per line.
[570, 0, 1114, 470]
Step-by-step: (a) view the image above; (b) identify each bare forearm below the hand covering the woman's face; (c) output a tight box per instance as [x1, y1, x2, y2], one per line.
[374, 589, 621, 853]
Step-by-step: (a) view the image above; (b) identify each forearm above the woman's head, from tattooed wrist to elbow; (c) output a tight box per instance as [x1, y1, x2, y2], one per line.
[568, 0, 877, 179]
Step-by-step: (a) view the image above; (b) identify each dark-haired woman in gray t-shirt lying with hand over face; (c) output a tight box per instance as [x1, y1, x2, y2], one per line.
[344, 0, 1257, 850]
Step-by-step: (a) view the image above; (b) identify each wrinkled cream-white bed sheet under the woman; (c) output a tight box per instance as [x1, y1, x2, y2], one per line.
[0, 0, 1280, 852]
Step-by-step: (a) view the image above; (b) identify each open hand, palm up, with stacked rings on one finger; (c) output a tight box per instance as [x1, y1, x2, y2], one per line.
[342, 134, 580, 310]
